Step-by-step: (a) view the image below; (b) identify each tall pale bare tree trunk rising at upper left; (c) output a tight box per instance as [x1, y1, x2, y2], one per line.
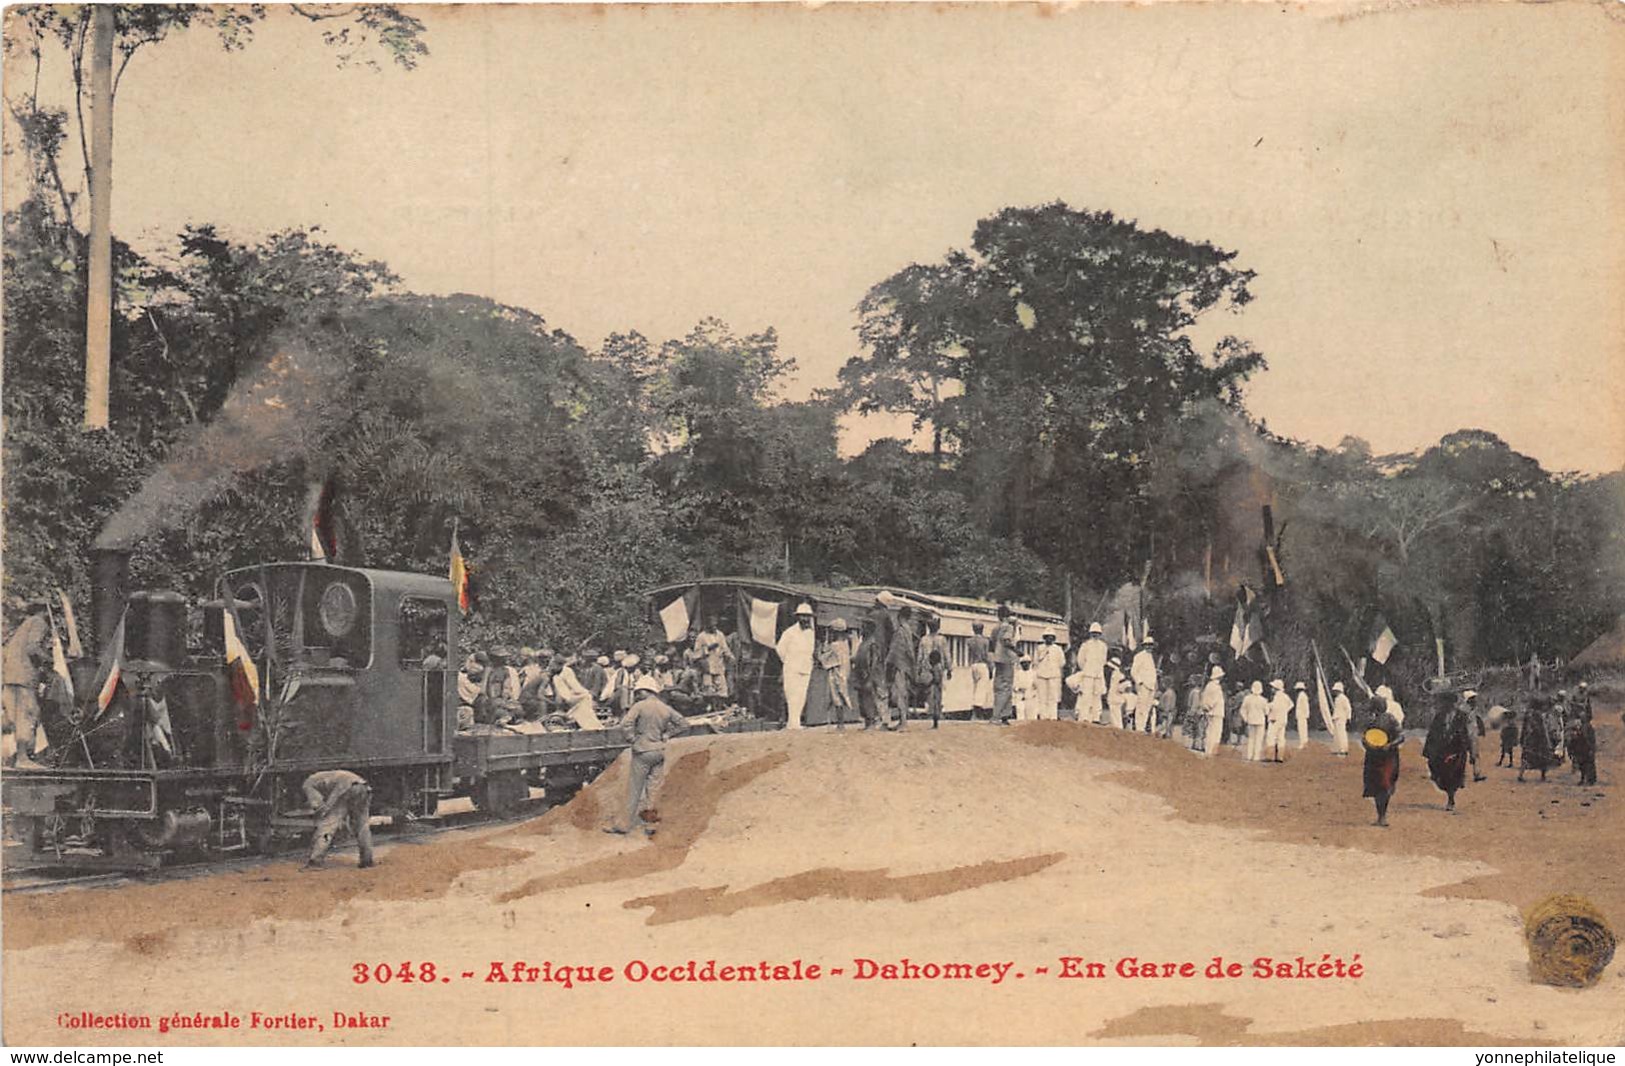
[85, 3, 115, 429]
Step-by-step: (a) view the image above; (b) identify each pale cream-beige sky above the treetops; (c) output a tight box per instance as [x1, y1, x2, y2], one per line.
[7, 3, 1625, 473]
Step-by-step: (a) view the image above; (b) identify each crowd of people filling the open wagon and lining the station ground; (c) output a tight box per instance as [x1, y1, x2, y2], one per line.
[442, 593, 1596, 830]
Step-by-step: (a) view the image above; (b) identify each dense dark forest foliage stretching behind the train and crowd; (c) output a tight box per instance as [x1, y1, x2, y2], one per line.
[3, 190, 1625, 668]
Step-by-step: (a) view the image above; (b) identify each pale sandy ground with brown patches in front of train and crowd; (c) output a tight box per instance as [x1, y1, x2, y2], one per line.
[3, 710, 1625, 1045]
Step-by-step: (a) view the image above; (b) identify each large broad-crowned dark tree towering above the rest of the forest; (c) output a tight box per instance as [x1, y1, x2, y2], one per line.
[842, 203, 1263, 585]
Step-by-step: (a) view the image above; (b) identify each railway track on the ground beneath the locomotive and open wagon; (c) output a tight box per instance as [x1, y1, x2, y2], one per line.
[0, 788, 556, 895]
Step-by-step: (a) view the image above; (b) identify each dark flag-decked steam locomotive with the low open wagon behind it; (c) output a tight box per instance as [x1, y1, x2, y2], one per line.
[0, 553, 572, 868]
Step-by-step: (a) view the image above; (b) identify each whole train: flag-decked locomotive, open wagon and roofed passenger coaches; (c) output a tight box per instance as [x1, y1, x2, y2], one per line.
[9, 551, 1064, 869]
